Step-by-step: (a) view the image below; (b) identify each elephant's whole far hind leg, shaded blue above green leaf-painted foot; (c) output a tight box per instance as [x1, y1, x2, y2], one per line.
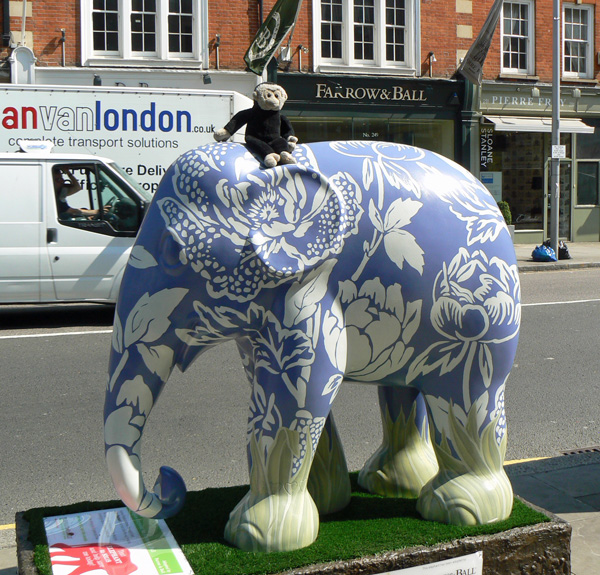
[358, 386, 438, 498]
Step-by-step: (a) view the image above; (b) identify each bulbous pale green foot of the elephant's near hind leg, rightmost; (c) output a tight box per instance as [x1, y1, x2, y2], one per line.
[417, 469, 513, 525]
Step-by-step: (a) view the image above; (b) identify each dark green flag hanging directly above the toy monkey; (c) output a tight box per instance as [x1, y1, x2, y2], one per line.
[244, 0, 302, 76]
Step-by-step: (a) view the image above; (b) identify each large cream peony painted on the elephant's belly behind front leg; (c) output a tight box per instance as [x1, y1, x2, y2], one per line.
[323, 278, 422, 381]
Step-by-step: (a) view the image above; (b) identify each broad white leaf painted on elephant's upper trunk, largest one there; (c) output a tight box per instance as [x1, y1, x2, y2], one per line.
[124, 288, 189, 347]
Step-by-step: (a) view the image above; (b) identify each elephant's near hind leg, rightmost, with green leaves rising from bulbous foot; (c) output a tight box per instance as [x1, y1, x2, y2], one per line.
[417, 365, 513, 525]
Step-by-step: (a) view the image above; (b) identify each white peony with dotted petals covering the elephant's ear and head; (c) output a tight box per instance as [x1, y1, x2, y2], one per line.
[157, 147, 363, 301]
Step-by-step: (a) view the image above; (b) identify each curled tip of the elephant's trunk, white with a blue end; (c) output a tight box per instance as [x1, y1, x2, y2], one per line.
[106, 445, 186, 519]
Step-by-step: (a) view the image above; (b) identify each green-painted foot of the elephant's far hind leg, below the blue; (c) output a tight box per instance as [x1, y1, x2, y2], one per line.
[358, 406, 438, 499]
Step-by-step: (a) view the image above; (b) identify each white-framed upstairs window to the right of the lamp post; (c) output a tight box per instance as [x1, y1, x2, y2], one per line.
[563, 4, 594, 78]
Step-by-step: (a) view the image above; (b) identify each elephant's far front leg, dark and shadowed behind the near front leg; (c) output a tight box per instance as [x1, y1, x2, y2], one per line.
[308, 413, 351, 515]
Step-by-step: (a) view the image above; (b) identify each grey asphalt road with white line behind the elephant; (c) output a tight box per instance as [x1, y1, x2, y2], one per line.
[0, 269, 600, 532]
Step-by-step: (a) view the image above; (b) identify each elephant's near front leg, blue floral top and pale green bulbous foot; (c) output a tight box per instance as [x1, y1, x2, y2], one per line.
[225, 360, 341, 552]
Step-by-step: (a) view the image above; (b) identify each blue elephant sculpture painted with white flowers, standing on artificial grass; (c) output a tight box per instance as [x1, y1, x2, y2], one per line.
[105, 142, 521, 551]
